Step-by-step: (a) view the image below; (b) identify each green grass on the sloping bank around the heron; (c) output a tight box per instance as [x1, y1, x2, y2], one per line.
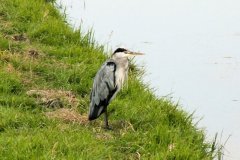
[0, 0, 219, 160]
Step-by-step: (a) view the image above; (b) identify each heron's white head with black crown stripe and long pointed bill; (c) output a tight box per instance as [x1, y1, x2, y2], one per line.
[112, 48, 144, 59]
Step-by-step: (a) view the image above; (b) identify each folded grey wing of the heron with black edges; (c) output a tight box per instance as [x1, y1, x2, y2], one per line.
[89, 60, 117, 120]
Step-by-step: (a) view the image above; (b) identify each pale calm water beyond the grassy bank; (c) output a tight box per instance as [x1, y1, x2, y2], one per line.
[57, 0, 240, 160]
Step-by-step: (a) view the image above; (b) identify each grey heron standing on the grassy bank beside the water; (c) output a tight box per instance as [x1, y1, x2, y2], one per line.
[88, 48, 143, 129]
